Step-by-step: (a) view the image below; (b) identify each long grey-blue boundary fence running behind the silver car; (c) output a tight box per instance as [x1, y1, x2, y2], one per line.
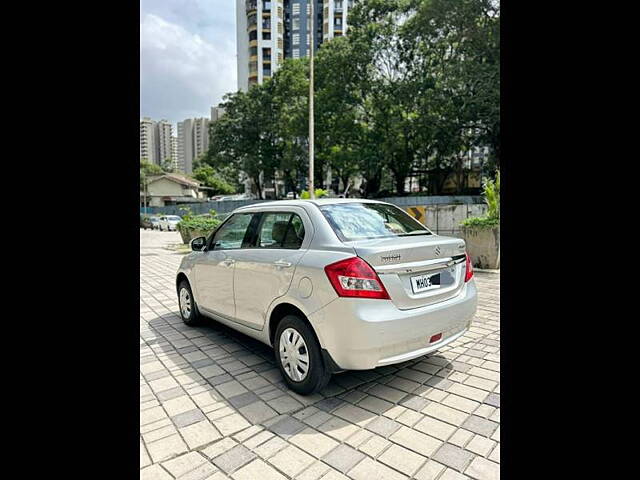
[140, 195, 487, 236]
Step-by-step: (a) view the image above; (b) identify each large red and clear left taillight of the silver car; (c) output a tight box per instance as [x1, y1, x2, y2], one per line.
[324, 257, 389, 299]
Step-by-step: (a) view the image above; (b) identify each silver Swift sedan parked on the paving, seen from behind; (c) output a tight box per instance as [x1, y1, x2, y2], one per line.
[176, 199, 477, 395]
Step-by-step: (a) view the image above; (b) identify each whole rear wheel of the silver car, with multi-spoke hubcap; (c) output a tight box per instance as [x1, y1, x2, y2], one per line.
[274, 315, 331, 395]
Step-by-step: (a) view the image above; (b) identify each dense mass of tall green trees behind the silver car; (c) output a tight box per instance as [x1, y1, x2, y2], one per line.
[206, 0, 500, 197]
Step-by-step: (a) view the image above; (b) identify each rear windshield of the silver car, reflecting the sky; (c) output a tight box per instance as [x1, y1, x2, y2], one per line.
[320, 203, 431, 242]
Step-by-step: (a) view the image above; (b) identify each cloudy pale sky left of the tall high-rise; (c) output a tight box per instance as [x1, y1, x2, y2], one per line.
[140, 0, 237, 126]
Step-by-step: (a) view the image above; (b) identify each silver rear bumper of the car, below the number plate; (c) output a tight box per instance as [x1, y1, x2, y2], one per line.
[309, 280, 477, 370]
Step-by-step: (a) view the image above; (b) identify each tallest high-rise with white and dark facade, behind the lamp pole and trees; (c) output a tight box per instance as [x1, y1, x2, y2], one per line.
[236, 0, 353, 91]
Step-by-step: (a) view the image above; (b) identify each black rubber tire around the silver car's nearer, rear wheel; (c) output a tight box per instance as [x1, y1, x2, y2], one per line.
[274, 315, 331, 395]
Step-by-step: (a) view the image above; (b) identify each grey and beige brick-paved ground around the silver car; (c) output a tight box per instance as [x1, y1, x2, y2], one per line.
[140, 231, 500, 480]
